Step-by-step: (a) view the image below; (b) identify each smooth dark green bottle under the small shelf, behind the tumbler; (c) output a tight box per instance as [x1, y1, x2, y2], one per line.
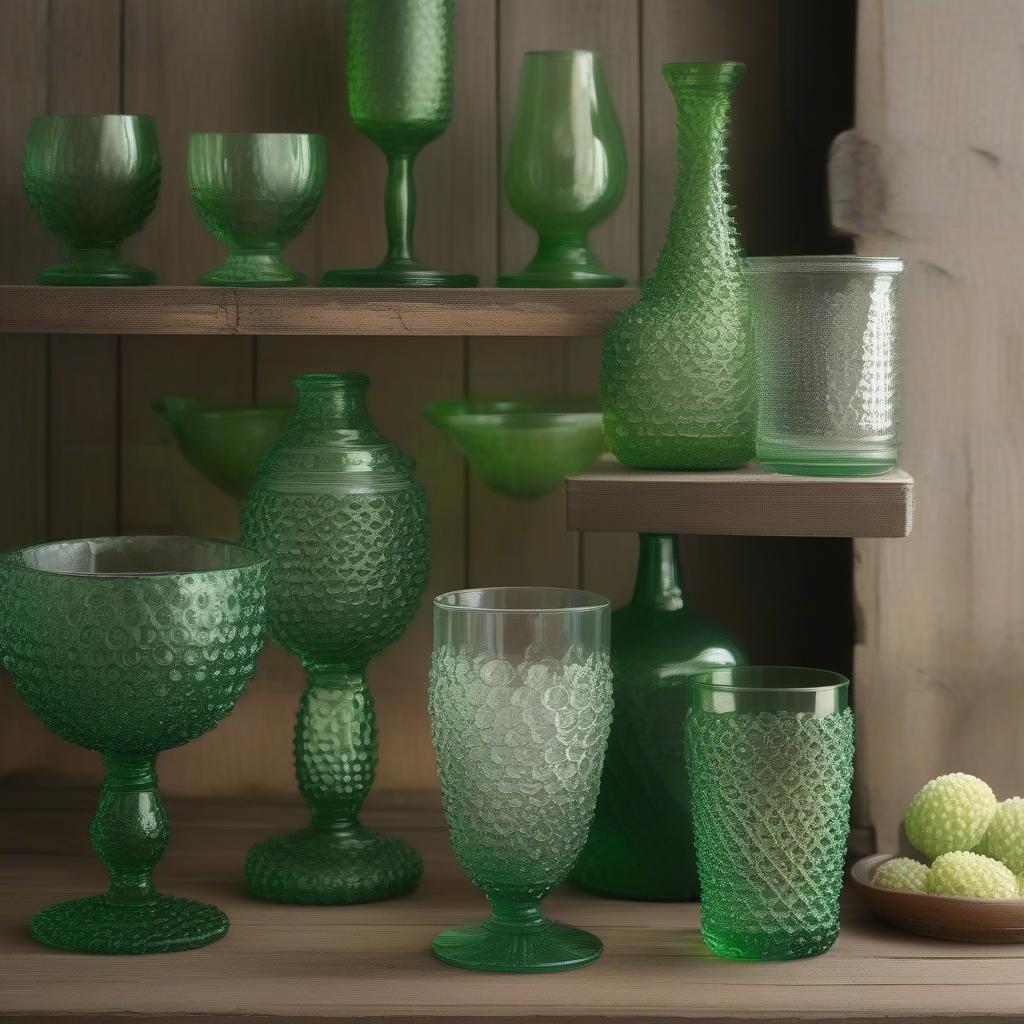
[572, 534, 746, 900]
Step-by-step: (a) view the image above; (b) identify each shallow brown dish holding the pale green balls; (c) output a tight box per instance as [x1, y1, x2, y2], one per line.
[850, 853, 1024, 942]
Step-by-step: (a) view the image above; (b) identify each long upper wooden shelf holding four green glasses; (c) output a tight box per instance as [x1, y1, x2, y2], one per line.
[0, 285, 638, 338]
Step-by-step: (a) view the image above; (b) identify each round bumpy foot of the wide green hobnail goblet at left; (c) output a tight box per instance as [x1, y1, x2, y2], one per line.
[29, 893, 228, 954]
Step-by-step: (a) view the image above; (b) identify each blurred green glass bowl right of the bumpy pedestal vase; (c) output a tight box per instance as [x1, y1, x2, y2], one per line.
[423, 395, 606, 501]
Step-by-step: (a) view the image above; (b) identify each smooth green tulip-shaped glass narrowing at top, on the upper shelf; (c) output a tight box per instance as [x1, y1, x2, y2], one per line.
[498, 50, 626, 288]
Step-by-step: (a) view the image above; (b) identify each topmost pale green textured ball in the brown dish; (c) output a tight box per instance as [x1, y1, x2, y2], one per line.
[903, 772, 996, 859]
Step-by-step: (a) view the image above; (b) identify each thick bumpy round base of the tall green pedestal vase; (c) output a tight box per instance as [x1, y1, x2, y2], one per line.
[246, 825, 423, 904]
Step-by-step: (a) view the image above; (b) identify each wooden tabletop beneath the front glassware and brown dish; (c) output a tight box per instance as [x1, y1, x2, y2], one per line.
[0, 791, 1024, 1024]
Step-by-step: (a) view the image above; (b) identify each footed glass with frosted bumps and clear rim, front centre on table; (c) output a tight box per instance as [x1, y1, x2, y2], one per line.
[430, 587, 611, 973]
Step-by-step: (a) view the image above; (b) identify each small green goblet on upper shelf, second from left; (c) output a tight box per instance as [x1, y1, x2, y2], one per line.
[188, 133, 327, 288]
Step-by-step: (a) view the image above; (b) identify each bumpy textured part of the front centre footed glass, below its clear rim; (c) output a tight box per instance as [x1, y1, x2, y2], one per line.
[429, 644, 611, 900]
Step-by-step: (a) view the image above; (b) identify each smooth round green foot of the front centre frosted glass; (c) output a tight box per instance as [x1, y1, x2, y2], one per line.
[430, 920, 603, 974]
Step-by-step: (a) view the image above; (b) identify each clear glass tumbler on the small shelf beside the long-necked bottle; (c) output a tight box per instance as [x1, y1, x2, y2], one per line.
[746, 256, 903, 476]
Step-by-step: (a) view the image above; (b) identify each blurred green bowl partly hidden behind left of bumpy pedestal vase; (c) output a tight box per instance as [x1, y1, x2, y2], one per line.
[153, 397, 295, 500]
